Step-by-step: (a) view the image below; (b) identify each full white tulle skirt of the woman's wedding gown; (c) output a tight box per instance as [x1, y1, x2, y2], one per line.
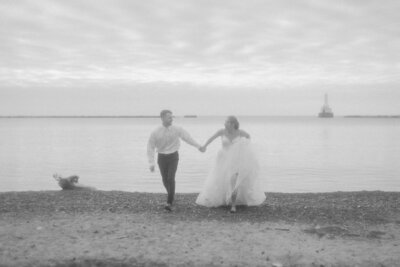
[196, 138, 265, 207]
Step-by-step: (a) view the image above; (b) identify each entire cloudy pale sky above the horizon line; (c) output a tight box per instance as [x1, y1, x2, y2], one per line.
[0, 0, 400, 116]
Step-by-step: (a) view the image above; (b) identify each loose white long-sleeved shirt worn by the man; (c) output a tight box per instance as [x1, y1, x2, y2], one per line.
[147, 125, 201, 166]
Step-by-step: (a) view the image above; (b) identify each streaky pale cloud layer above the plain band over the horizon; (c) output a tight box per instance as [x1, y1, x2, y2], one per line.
[0, 0, 400, 91]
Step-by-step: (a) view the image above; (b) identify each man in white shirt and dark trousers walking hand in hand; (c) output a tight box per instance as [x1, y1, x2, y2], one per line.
[147, 110, 203, 211]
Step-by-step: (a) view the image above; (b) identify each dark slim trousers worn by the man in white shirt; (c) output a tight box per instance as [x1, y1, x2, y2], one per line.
[157, 151, 179, 204]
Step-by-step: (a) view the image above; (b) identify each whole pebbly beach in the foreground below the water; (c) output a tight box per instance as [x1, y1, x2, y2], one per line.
[0, 190, 400, 266]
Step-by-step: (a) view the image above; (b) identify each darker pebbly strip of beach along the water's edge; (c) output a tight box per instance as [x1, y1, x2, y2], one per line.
[0, 190, 400, 224]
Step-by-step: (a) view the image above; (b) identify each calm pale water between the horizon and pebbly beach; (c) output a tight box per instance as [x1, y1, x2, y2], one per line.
[0, 117, 400, 192]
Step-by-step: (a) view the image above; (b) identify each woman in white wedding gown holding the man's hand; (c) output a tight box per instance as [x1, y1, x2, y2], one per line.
[196, 116, 265, 213]
